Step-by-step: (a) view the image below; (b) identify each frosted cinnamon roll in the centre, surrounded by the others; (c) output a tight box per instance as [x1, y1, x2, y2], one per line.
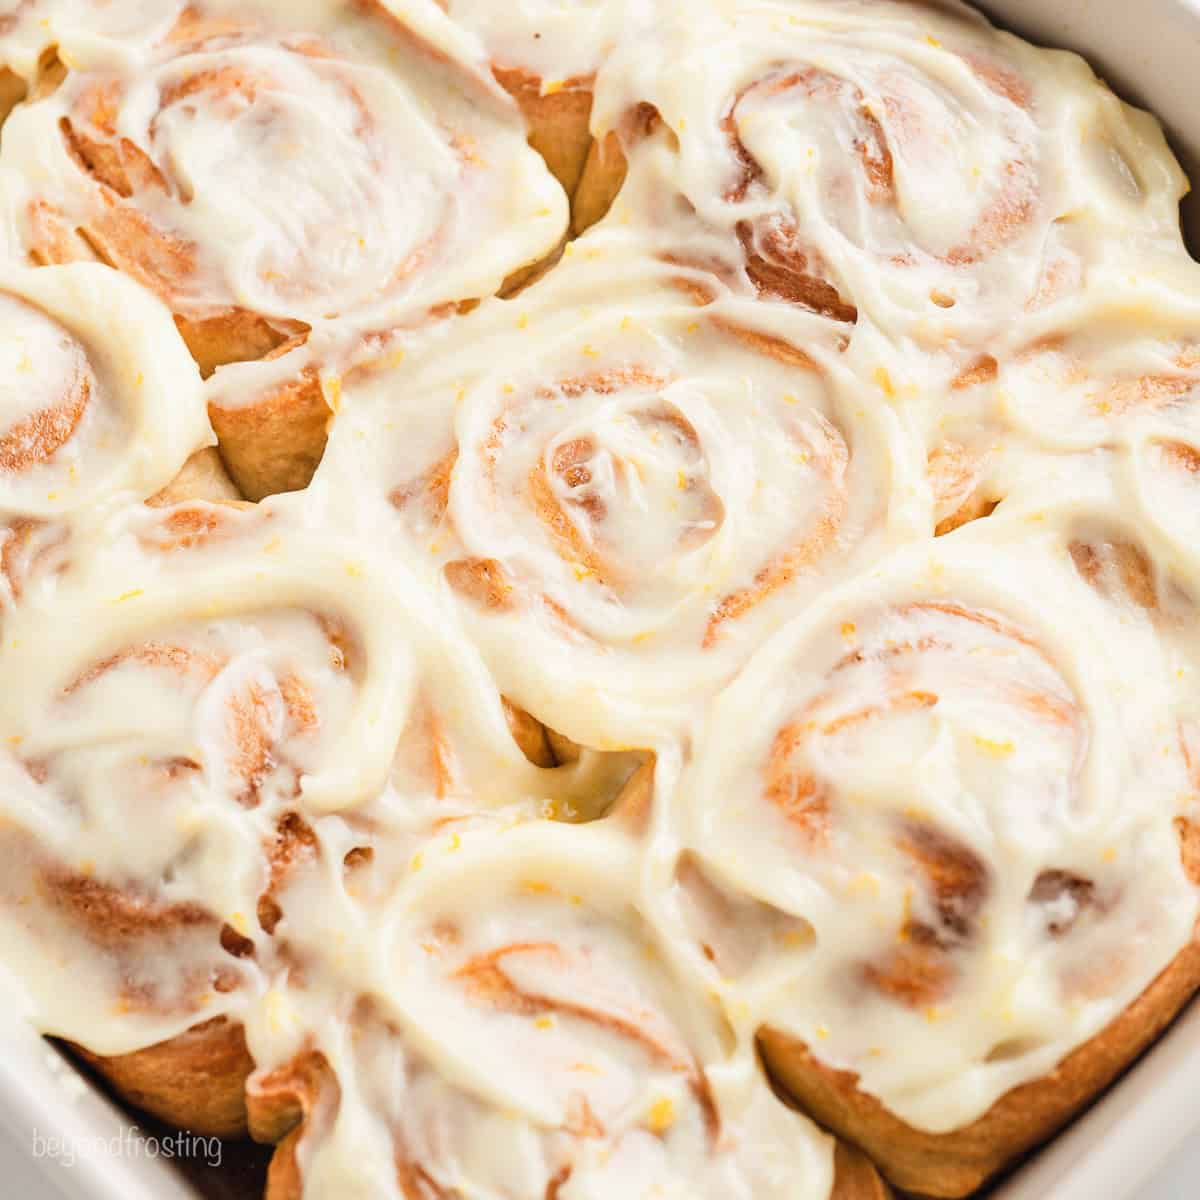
[308, 242, 896, 746]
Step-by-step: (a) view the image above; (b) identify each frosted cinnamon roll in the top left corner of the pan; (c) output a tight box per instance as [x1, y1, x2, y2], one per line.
[4, 0, 565, 498]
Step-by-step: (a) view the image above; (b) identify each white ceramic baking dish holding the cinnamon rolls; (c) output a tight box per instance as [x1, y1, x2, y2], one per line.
[0, 0, 1200, 1200]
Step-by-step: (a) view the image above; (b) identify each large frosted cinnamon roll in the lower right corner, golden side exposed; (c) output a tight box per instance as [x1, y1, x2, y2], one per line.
[661, 520, 1200, 1196]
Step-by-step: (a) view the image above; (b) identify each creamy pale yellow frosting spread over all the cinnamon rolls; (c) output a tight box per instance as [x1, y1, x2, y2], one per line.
[0, 0, 1200, 1200]
